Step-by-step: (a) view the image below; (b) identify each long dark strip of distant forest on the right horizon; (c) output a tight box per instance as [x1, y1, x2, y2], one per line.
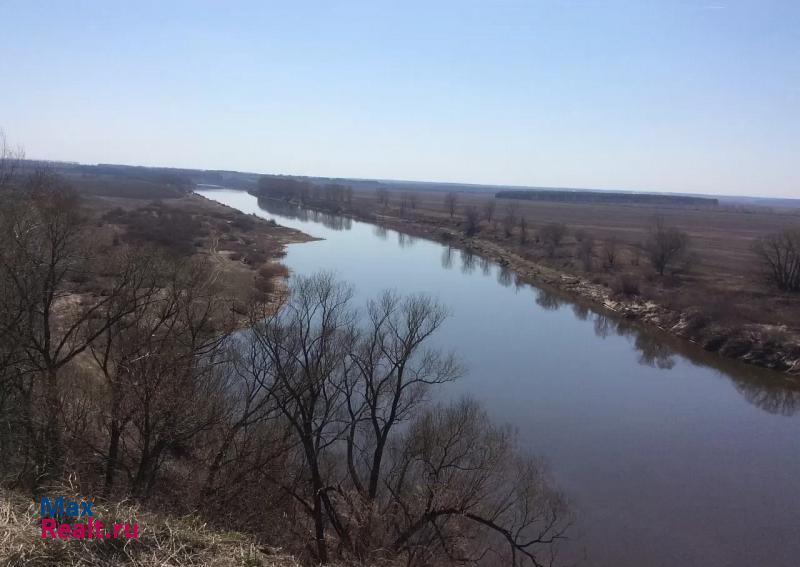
[494, 189, 719, 207]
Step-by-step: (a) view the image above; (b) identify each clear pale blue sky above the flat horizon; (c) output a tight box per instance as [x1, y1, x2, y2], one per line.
[0, 0, 800, 197]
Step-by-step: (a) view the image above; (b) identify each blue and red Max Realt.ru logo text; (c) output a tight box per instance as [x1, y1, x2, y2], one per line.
[39, 496, 139, 539]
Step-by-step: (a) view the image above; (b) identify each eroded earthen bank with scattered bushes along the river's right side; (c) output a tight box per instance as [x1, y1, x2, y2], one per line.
[262, 197, 800, 376]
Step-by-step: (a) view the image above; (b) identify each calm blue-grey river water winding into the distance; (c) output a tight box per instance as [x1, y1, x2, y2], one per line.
[198, 189, 800, 567]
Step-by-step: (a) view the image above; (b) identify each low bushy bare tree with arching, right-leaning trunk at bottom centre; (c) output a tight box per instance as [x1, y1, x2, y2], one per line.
[387, 400, 571, 566]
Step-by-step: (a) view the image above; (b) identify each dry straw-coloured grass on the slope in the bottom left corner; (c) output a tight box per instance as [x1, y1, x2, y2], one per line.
[0, 489, 300, 567]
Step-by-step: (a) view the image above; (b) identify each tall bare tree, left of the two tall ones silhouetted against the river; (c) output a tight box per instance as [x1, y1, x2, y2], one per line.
[247, 274, 355, 563]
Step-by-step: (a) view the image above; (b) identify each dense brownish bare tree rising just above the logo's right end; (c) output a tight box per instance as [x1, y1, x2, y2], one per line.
[88, 255, 232, 497]
